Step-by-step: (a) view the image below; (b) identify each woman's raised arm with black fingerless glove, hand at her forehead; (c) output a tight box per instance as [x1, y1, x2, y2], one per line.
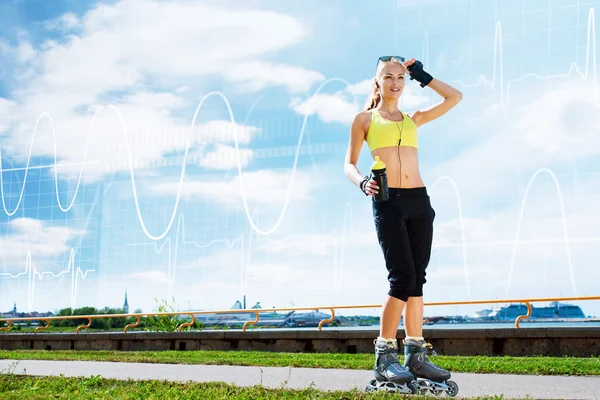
[405, 59, 462, 126]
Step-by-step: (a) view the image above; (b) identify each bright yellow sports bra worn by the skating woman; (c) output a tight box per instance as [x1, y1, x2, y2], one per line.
[365, 109, 419, 152]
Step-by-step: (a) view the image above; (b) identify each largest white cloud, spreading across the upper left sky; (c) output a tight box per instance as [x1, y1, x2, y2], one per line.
[0, 0, 323, 181]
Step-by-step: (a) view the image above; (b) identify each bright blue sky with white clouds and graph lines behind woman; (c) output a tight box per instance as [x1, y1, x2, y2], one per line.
[0, 0, 600, 315]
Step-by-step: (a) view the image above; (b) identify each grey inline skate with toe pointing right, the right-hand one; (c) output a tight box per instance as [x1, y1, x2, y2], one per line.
[404, 339, 458, 397]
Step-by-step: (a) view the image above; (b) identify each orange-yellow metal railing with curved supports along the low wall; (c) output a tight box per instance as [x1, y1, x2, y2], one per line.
[0, 296, 600, 334]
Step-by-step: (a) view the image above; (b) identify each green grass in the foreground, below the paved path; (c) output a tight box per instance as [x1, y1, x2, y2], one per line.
[0, 374, 501, 400]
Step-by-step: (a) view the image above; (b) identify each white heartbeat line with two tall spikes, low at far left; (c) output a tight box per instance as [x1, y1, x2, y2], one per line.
[0, 249, 94, 311]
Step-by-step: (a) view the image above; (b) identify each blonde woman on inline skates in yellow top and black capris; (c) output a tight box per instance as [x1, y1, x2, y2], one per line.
[345, 56, 462, 390]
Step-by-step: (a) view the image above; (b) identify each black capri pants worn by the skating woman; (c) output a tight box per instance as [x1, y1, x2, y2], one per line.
[373, 187, 435, 301]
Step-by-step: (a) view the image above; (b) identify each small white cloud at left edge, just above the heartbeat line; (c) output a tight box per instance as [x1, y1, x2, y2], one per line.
[0, 218, 85, 266]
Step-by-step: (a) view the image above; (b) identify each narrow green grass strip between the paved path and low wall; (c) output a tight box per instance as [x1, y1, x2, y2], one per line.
[0, 350, 600, 375]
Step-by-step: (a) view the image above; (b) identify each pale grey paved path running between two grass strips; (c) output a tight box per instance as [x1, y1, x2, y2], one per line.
[0, 360, 600, 400]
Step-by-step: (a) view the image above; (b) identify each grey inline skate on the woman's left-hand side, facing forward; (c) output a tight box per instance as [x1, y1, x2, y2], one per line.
[365, 339, 417, 394]
